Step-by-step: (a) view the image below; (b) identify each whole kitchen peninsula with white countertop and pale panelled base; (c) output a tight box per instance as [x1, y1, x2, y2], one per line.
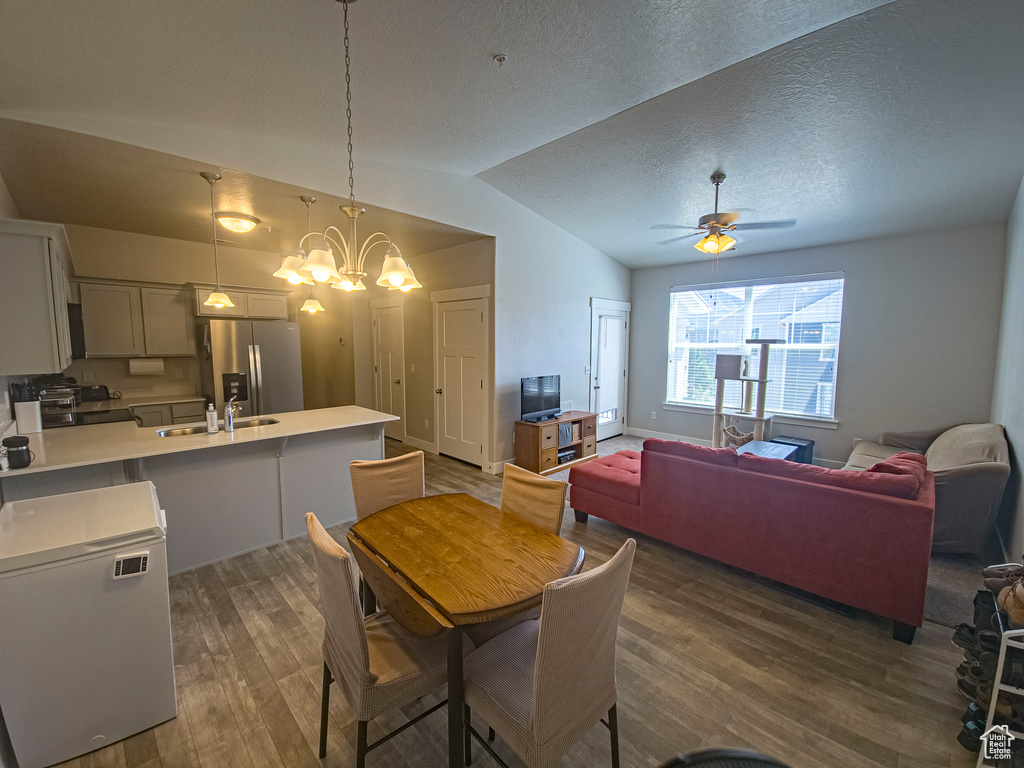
[0, 406, 397, 573]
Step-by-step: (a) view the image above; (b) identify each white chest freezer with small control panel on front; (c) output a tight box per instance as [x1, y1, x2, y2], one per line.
[0, 482, 177, 768]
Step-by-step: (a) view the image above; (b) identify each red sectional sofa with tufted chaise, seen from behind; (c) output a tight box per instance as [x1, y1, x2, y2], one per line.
[569, 439, 935, 643]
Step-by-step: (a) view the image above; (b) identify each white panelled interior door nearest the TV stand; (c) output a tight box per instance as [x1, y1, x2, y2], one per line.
[434, 299, 487, 466]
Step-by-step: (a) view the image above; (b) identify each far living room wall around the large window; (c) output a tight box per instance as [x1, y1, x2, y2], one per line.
[628, 225, 1006, 462]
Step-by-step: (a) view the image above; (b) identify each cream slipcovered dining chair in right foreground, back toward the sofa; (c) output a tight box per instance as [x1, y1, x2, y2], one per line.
[465, 539, 636, 768]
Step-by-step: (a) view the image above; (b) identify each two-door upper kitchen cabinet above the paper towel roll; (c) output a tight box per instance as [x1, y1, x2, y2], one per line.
[80, 283, 196, 357]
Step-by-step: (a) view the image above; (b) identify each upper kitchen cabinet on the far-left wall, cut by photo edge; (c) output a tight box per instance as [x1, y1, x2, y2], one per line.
[0, 219, 72, 376]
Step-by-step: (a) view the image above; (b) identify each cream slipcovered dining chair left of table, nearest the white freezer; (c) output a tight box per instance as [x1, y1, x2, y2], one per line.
[306, 512, 447, 768]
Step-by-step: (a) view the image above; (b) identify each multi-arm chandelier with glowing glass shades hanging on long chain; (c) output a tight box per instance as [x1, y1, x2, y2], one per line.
[274, 0, 423, 296]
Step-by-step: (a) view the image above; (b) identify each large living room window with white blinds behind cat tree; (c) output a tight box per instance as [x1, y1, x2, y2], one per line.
[667, 274, 843, 419]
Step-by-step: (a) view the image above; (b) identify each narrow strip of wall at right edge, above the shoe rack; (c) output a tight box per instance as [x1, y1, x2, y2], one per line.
[992, 180, 1024, 559]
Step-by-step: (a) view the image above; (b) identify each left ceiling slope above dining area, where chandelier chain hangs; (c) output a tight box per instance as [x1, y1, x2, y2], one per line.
[0, 0, 885, 173]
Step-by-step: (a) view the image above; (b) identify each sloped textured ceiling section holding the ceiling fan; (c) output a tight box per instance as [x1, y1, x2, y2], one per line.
[480, 0, 1024, 267]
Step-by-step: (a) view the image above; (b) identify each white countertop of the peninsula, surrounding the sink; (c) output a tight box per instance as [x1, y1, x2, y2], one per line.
[0, 405, 398, 479]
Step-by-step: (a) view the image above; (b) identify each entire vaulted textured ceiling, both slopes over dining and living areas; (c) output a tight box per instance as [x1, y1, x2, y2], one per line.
[0, 0, 1024, 266]
